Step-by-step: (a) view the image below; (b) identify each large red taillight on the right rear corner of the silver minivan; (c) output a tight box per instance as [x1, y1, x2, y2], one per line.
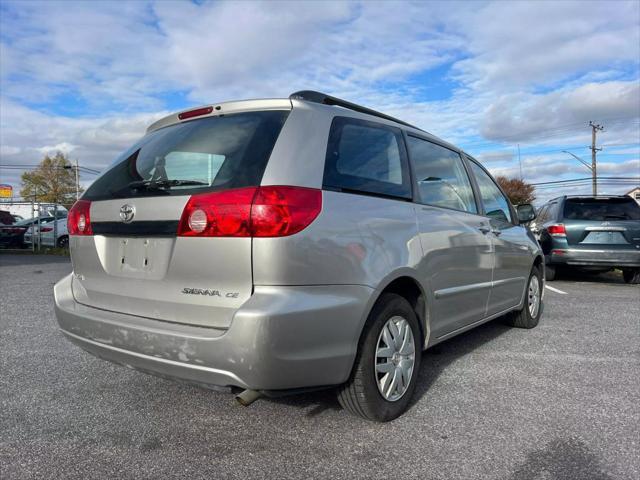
[178, 186, 322, 237]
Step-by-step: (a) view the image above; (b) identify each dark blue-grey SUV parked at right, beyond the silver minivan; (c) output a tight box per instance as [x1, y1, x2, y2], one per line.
[531, 196, 640, 284]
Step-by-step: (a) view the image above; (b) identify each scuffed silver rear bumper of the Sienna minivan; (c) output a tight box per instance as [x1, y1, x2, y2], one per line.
[55, 275, 374, 390]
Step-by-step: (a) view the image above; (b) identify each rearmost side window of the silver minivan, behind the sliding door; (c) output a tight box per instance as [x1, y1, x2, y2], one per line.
[323, 117, 411, 199]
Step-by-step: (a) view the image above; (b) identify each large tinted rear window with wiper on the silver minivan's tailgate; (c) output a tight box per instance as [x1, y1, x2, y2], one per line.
[83, 111, 288, 200]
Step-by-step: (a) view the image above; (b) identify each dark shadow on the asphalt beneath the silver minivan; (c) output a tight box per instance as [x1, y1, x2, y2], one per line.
[265, 318, 511, 417]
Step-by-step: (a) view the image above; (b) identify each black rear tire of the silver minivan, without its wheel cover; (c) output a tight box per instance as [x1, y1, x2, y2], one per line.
[338, 293, 422, 422]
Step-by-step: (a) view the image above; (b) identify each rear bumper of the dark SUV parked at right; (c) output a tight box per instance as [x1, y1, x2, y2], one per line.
[546, 248, 640, 268]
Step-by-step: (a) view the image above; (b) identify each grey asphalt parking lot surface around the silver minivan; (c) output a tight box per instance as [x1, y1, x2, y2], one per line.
[0, 254, 640, 480]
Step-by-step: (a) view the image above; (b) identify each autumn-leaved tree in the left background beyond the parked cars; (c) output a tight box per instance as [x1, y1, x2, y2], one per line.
[20, 152, 82, 208]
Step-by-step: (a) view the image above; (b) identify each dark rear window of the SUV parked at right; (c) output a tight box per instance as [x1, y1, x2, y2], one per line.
[564, 198, 640, 221]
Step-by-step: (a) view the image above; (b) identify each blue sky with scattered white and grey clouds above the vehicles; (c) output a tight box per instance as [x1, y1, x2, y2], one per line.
[0, 0, 640, 199]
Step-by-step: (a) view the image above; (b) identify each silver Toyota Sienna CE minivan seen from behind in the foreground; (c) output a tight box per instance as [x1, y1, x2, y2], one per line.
[55, 91, 544, 421]
